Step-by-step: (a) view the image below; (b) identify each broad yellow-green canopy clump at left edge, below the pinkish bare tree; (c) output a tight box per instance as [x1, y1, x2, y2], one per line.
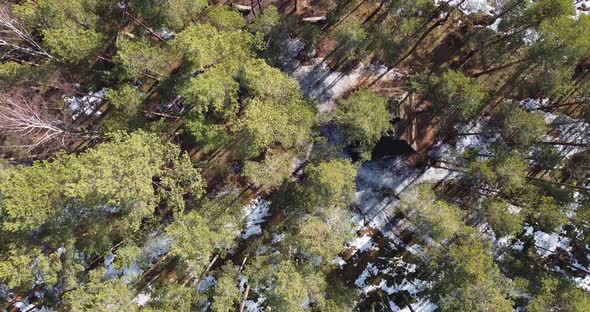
[0, 132, 203, 254]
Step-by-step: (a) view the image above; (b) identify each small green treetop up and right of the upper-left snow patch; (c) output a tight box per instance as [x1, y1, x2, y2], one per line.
[116, 38, 176, 80]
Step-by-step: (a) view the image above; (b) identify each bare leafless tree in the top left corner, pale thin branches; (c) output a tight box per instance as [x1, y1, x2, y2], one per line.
[0, 6, 58, 61]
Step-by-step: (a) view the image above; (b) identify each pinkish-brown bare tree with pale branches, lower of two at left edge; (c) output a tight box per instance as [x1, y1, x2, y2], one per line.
[0, 95, 93, 150]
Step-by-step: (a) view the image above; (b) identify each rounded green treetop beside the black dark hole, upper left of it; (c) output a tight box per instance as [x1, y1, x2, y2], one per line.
[334, 89, 392, 159]
